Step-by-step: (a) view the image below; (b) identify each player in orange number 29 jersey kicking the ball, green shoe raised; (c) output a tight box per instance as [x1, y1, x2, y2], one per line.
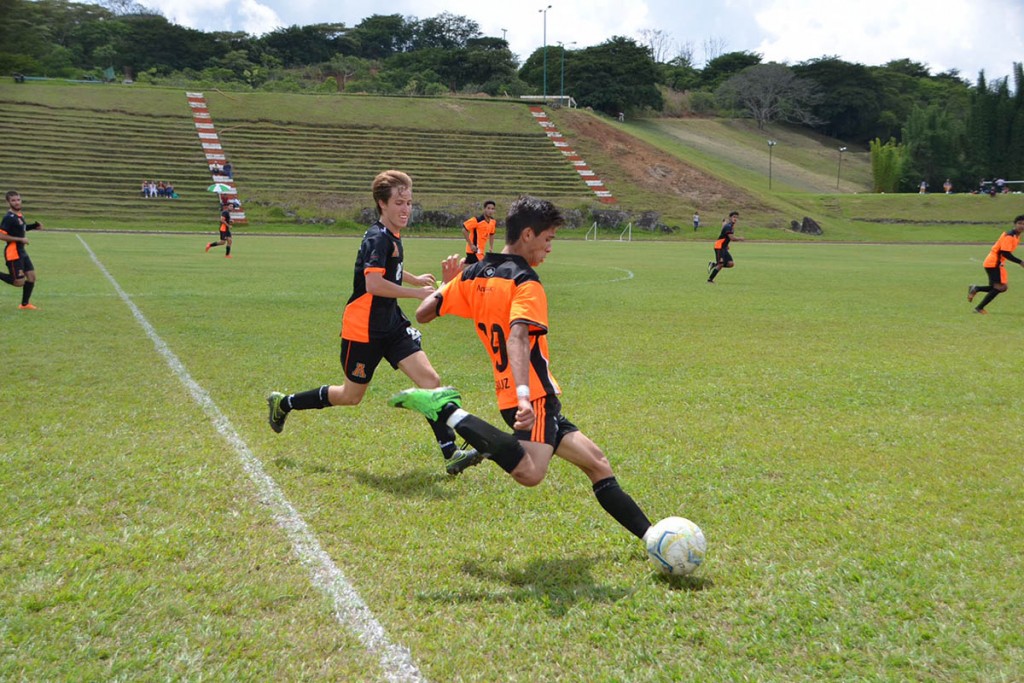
[388, 197, 650, 539]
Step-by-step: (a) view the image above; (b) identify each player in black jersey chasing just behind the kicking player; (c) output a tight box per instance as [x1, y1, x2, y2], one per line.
[266, 170, 481, 474]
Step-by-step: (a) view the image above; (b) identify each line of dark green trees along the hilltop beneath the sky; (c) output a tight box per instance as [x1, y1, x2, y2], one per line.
[0, 0, 1024, 191]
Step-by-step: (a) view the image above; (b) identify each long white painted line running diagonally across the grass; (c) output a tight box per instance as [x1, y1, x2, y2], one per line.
[76, 236, 426, 683]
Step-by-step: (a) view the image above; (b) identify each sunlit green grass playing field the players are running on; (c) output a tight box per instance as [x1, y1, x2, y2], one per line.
[0, 232, 1024, 682]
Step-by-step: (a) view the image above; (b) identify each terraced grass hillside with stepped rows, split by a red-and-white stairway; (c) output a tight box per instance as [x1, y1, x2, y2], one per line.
[0, 84, 594, 228]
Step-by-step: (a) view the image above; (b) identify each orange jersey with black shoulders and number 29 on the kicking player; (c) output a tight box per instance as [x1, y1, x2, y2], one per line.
[437, 253, 561, 409]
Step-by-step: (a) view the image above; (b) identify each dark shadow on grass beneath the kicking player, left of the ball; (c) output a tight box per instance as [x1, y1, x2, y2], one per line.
[413, 557, 634, 616]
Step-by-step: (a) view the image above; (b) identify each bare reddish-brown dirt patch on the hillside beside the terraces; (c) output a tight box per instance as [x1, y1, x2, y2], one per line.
[557, 110, 773, 218]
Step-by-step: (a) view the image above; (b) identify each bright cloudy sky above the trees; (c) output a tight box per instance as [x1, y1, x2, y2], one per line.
[153, 0, 1024, 82]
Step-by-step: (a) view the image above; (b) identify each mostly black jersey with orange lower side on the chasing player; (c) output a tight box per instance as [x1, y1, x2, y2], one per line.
[341, 221, 409, 342]
